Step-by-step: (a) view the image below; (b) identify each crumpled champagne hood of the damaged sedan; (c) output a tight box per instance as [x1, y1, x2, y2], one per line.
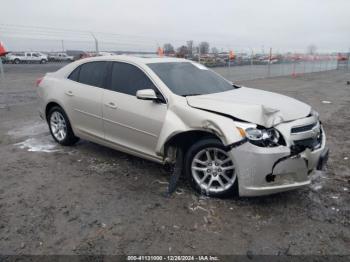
[187, 87, 311, 127]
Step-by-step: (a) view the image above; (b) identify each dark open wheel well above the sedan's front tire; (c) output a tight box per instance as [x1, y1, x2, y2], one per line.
[164, 130, 221, 160]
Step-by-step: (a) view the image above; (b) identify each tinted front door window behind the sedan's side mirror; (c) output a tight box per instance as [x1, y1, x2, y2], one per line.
[111, 62, 156, 96]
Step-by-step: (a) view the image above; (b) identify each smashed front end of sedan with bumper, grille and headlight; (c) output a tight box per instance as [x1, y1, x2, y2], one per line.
[230, 112, 328, 196]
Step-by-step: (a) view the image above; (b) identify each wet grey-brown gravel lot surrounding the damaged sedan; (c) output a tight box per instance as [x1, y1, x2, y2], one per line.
[0, 64, 350, 255]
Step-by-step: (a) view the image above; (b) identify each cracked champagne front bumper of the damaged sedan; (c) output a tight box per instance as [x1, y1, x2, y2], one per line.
[229, 127, 328, 196]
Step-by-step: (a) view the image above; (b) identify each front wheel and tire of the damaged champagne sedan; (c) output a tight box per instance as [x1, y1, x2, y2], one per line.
[184, 138, 238, 197]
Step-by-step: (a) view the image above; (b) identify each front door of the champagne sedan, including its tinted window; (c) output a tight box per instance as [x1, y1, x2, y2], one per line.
[103, 62, 167, 157]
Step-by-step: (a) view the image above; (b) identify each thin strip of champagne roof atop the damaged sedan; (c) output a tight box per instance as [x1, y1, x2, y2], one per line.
[80, 55, 192, 64]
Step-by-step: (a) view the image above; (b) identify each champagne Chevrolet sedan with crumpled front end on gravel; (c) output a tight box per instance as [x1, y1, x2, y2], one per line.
[37, 56, 328, 196]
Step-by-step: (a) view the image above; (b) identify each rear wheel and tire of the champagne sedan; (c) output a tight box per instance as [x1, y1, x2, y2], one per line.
[47, 106, 79, 146]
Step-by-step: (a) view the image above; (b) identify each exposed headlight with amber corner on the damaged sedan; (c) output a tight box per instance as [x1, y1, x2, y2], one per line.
[235, 122, 285, 147]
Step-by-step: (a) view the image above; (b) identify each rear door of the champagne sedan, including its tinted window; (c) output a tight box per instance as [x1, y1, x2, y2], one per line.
[64, 61, 108, 138]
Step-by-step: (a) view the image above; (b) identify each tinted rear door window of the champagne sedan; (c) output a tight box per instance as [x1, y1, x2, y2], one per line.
[76, 62, 107, 87]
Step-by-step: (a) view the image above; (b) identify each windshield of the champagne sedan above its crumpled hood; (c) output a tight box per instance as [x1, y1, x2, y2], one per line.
[147, 62, 234, 96]
